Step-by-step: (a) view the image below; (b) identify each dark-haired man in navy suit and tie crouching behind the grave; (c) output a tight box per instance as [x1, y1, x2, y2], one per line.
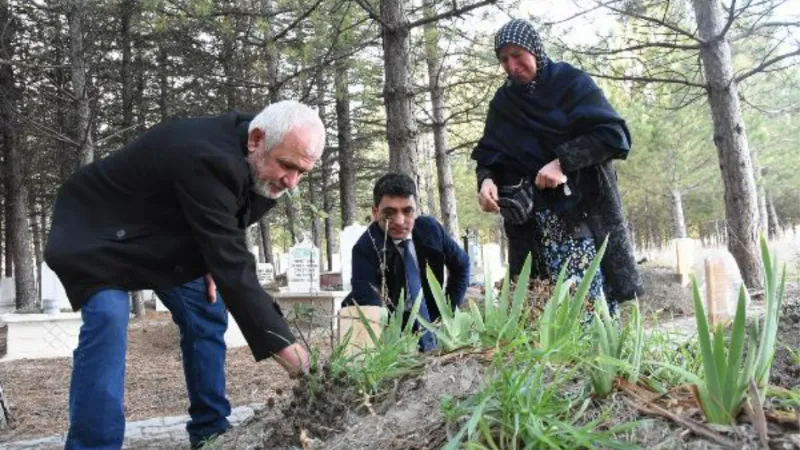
[343, 173, 469, 351]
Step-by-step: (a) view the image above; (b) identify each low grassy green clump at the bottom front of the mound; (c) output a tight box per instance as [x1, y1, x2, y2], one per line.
[443, 347, 633, 450]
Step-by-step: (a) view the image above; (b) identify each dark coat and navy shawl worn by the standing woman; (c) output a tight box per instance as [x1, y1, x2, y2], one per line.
[472, 62, 644, 301]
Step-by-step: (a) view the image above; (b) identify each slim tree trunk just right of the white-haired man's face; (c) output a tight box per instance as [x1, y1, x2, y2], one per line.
[334, 59, 358, 228]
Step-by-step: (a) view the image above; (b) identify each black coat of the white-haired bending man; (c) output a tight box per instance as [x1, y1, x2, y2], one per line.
[45, 112, 294, 360]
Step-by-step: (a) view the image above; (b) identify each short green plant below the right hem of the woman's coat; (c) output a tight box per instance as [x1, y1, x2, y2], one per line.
[589, 298, 644, 398]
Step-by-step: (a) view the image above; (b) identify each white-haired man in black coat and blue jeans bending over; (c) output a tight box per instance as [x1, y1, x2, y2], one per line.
[45, 101, 325, 450]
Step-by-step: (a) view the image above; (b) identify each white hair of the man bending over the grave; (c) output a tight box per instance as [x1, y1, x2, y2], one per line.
[248, 100, 325, 156]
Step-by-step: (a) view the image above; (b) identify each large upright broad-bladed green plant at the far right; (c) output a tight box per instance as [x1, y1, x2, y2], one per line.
[676, 235, 785, 424]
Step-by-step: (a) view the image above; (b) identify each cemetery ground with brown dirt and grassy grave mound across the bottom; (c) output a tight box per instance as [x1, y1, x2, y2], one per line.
[0, 237, 800, 450]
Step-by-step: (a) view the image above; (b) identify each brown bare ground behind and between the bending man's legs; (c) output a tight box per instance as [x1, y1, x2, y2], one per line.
[0, 311, 295, 443]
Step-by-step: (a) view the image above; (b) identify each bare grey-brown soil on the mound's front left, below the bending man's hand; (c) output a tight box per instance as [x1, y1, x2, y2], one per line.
[223, 359, 483, 450]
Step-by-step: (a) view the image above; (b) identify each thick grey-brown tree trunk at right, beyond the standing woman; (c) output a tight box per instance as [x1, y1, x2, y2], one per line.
[693, 0, 762, 290]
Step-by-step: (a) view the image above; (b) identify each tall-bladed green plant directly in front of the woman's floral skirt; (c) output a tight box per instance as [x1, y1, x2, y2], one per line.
[539, 238, 608, 350]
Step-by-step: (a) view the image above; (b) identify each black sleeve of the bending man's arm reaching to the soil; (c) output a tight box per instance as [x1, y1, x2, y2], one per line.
[175, 157, 295, 361]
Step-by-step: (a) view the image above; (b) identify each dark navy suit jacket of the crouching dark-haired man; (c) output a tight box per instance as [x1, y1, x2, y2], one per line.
[343, 216, 469, 321]
